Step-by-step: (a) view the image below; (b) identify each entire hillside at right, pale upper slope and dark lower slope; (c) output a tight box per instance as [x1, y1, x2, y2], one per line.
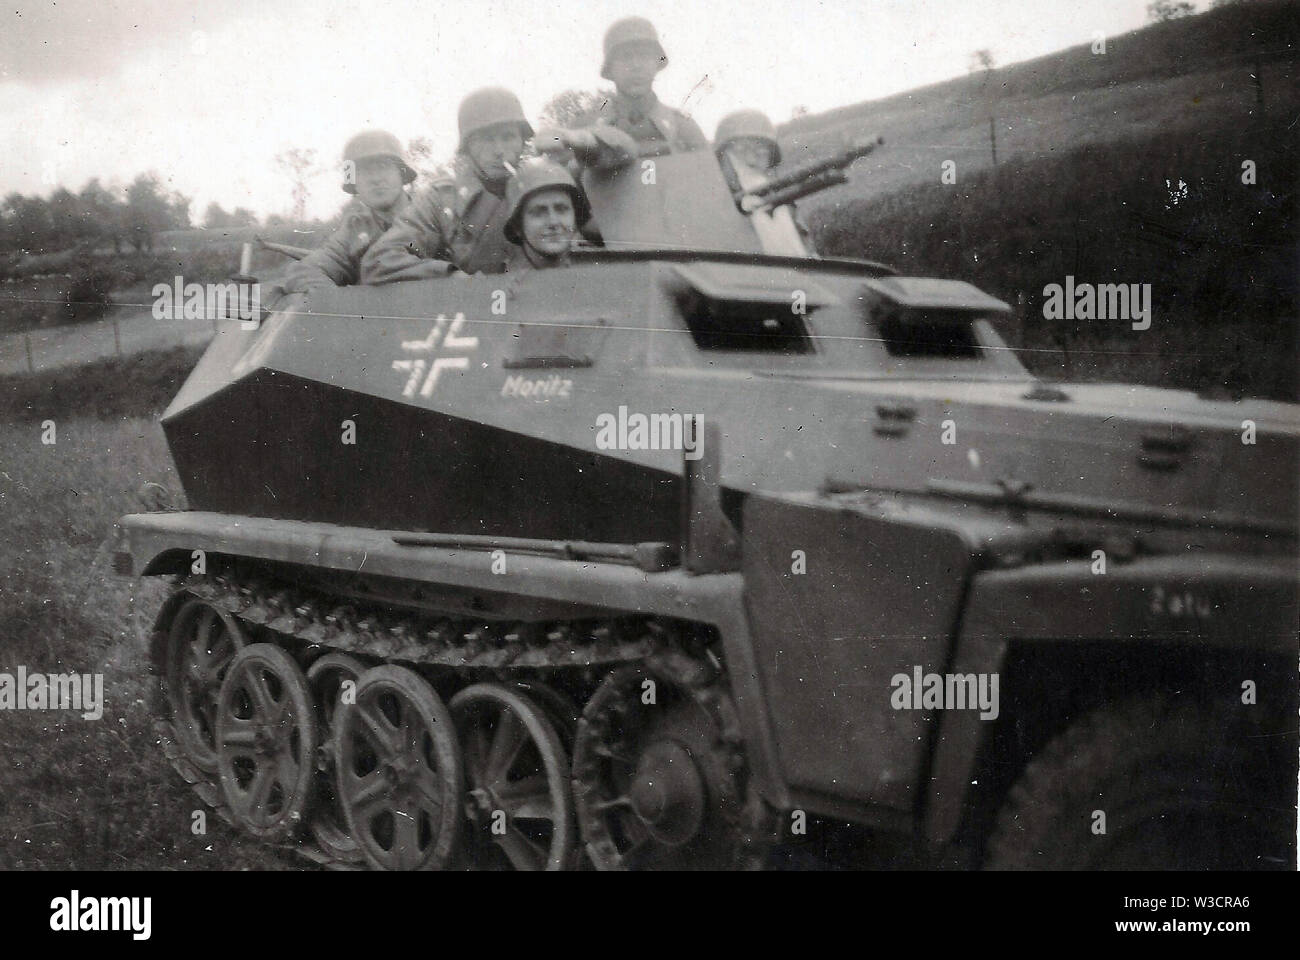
[797, 0, 1300, 399]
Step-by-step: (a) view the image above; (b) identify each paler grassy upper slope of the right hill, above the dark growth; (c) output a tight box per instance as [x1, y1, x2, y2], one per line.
[783, 0, 1300, 214]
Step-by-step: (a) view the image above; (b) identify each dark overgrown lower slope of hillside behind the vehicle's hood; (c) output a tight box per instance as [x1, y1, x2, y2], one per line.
[810, 118, 1297, 399]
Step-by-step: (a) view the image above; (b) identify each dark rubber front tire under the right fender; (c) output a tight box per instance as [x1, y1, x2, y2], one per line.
[983, 696, 1295, 870]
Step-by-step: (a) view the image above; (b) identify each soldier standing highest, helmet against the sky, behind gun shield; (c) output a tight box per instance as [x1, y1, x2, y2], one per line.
[599, 17, 709, 156]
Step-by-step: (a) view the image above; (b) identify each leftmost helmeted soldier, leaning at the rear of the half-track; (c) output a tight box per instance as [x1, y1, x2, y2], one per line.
[280, 130, 415, 293]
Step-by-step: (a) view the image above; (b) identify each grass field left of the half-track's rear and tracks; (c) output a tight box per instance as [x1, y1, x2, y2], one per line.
[0, 354, 297, 870]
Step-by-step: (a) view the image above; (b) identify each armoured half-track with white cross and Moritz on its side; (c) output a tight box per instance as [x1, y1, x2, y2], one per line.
[117, 147, 1300, 869]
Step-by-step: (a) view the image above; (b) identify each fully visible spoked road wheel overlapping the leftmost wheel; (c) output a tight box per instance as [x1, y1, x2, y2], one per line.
[217, 644, 317, 840]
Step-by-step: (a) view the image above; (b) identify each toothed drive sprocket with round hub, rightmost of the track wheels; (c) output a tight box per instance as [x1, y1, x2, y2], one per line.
[573, 654, 766, 870]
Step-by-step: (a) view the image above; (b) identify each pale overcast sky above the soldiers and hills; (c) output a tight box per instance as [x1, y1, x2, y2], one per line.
[0, 0, 1159, 222]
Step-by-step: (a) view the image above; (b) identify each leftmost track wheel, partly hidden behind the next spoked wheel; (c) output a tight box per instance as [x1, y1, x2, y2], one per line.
[165, 598, 248, 774]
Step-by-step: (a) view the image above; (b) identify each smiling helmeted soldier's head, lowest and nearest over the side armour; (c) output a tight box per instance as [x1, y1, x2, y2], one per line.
[506, 159, 592, 272]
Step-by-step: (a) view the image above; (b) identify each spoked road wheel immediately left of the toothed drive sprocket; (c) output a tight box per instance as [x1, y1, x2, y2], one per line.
[451, 683, 575, 870]
